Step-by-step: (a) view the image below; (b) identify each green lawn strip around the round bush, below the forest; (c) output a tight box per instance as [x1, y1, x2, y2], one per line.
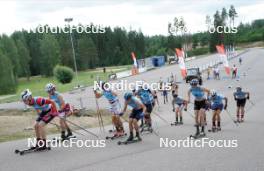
[0, 65, 130, 103]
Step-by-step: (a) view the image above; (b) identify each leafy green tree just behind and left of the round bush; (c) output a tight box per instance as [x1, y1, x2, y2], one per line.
[40, 34, 61, 76]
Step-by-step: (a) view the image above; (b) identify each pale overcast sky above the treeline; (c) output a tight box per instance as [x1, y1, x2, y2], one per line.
[0, 0, 264, 35]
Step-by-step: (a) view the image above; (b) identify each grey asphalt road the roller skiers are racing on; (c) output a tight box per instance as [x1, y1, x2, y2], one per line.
[0, 49, 264, 171]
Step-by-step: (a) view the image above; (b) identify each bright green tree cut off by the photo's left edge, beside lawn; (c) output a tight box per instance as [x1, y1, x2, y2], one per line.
[0, 50, 17, 94]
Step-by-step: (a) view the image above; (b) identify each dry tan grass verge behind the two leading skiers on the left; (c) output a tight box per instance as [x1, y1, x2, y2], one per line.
[0, 110, 127, 143]
